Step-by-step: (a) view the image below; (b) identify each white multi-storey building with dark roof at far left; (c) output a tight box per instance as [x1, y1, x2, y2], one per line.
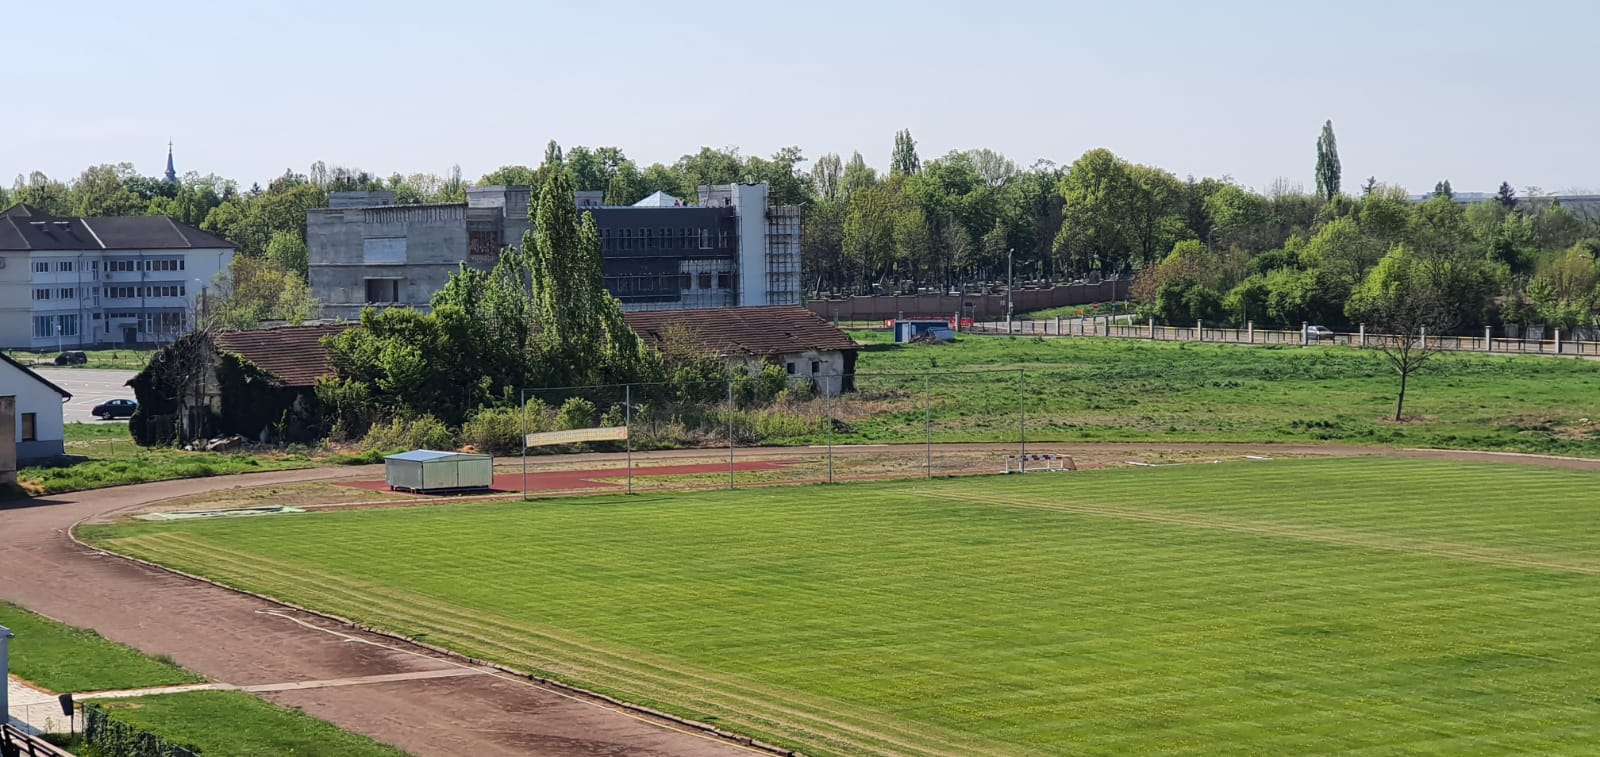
[0, 205, 234, 350]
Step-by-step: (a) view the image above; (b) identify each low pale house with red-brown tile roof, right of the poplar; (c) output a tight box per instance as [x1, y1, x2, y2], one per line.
[626, 306, 861, 395]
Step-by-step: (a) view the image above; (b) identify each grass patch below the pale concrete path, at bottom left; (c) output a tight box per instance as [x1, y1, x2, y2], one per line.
[78, 691, 405, 757]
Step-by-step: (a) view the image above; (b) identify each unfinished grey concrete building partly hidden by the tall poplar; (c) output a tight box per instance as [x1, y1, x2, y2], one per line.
[306, 184, 800, 318]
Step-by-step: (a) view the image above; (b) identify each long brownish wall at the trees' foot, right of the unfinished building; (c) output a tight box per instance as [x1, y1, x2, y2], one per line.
[805, 278, 1133, 320]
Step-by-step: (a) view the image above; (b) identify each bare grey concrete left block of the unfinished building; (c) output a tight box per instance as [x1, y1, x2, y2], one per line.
[306, 205, 467, 318]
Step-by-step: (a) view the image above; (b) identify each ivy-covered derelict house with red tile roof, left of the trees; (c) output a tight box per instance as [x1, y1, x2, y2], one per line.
[128, 323, 352, 443]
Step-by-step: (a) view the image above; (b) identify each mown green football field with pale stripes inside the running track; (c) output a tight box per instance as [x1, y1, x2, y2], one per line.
[90, 458, 1600, 755]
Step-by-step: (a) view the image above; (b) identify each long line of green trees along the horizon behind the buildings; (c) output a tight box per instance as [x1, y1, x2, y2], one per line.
[9, 122, 1600, 330]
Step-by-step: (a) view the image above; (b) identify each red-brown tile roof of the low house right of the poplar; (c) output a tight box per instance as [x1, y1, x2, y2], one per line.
[626, 306, 858, 357]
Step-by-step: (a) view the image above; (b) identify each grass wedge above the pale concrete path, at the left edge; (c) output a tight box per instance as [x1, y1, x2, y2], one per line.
[0, 602, 203, 691]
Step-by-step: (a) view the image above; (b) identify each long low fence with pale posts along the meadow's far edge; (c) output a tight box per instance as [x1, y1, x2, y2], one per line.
[963, 317, 1600, 355]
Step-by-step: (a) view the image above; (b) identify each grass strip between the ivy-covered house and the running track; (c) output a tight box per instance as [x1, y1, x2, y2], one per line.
[18, 423, 314, 495]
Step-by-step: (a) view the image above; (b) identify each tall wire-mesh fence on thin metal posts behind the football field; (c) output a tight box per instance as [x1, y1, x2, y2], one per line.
[508, 366, 1043, 495]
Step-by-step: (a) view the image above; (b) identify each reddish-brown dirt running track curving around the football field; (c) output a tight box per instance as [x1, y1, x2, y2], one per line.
[0, 443, 1600, 757]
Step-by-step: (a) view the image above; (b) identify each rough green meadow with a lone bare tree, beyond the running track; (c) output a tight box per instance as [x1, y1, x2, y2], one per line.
[838, 331, 1600, 456]
